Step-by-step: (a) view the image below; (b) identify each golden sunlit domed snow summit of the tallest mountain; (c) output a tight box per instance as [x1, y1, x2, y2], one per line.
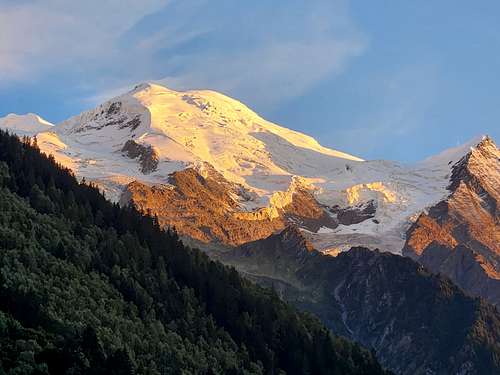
[55, 83, 361, 193]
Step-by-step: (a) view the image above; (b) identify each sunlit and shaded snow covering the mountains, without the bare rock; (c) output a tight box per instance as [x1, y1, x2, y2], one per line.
[0, 83, 479, 253]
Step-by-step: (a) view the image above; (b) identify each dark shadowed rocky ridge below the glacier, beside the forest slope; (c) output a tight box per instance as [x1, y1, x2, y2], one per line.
[218, 229, 500, 375]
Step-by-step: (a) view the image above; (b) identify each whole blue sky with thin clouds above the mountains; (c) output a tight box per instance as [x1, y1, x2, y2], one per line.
[0, 0, 500, 162]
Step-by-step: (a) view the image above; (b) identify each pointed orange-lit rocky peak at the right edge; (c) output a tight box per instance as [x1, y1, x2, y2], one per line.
[403, 138, 500, 304]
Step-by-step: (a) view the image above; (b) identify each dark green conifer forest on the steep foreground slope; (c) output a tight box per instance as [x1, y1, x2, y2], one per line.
[0, 131, 384, 374]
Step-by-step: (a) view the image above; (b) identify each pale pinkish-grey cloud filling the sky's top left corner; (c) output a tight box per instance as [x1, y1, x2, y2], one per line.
[0, 0, 167, 81]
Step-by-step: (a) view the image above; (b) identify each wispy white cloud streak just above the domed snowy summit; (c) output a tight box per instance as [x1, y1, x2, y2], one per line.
[162, 36, 362, 106]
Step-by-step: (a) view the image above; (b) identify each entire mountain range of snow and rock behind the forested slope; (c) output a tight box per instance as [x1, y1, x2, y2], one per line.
[0, 83, 500, 374]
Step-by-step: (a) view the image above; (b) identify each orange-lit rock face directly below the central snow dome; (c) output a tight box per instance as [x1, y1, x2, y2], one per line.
[120, 168, 337, 246]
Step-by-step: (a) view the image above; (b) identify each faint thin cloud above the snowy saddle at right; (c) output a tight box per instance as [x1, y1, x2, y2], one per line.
[329, 62, 440, 158]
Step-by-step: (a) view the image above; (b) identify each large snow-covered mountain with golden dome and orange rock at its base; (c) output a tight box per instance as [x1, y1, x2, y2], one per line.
[0, 84, 492, 253]
